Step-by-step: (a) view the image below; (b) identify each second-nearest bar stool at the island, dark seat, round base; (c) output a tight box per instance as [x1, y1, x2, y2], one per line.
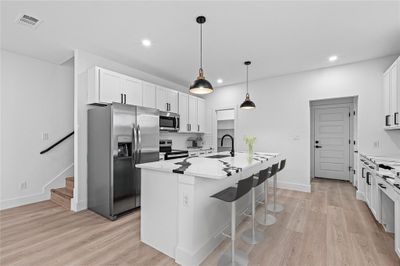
[241, 168, 271, 245]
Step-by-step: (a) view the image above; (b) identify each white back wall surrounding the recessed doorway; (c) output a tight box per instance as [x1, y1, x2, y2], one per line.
[206, 56, 400, 191]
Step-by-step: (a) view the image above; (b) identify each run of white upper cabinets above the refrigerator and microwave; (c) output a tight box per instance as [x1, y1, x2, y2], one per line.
[88, 66, 206, 133]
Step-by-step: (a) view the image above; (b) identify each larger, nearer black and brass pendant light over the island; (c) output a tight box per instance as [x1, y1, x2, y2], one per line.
[189, 16, 214, 94]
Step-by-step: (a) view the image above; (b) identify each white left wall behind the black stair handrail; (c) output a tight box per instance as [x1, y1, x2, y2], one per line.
[1, 50, 73, 209]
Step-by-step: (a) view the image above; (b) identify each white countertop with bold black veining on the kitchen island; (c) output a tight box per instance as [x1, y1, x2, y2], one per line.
[136, 152, 279, 179]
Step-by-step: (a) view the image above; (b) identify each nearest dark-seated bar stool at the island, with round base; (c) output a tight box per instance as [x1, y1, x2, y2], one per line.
[211, 176, 253, 266]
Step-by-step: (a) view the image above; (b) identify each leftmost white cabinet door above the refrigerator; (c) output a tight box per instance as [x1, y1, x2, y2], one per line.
[98, 68, 125, 103]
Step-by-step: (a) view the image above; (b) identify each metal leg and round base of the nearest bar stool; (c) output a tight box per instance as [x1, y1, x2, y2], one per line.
[218, 201, 249, 266]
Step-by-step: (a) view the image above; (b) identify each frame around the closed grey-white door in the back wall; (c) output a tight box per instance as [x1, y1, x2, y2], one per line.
[310, 96, 358, 185]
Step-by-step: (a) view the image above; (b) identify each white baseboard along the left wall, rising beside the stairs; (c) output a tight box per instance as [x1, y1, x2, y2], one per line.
[0, 163, 74, 210]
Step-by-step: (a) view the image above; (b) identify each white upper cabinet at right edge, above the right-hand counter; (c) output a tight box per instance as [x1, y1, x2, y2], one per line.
[383, 57, 400, 129]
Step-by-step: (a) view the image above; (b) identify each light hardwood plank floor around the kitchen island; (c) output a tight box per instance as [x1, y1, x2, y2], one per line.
[0, 179, 400, 266]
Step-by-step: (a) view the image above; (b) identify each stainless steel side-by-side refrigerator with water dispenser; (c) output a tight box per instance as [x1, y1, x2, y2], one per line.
[88, 103, 160, 220]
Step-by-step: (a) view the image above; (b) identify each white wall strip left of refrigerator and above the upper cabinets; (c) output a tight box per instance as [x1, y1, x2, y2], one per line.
[71, 50, 193, 211]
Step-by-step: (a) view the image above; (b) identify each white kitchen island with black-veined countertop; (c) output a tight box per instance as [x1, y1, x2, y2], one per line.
[137, 152, 279, 265]
